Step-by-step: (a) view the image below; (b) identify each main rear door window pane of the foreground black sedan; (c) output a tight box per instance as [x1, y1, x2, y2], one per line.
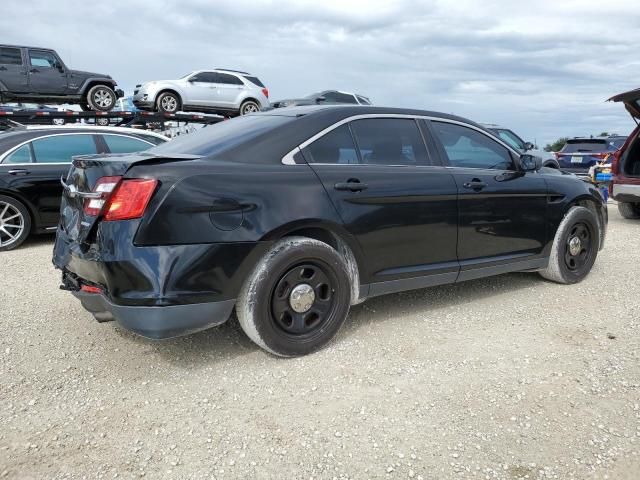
[351, 118, 430, 165]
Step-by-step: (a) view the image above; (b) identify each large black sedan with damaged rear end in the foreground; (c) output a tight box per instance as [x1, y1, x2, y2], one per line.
[53, 106, 607, 356]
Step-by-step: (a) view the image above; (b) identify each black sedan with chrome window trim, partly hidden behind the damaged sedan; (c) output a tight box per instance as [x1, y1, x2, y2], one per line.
[0, 126, 167, 252]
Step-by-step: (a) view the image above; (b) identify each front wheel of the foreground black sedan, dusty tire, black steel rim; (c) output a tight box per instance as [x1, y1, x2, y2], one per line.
[539, 207, 600, 284]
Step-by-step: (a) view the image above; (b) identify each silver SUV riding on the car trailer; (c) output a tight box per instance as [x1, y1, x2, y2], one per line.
[133, 69, 269, 116]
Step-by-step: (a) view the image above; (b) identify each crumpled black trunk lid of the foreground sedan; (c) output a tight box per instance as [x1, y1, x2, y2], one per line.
[60, 152, 200, 243]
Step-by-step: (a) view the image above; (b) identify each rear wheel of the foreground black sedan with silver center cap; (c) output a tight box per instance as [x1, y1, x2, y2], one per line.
[236, 237, 351, 357]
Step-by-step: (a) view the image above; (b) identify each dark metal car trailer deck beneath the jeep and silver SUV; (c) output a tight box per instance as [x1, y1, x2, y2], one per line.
[0, 110, 226, 131]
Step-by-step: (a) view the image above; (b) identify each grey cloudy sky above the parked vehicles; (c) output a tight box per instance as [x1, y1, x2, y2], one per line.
[0, 0, 640, 144]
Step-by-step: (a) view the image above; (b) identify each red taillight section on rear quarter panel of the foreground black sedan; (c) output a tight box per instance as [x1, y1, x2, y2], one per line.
[104, 178, 158, 222]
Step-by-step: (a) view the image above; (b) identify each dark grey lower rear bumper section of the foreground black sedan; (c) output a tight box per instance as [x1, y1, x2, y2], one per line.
[72, 291, 235, 339]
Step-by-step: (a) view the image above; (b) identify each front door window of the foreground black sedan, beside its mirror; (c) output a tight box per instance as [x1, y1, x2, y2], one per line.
[432, 122, 515, 170]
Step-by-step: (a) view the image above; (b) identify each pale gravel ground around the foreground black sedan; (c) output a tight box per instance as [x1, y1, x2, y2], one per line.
[0, 206, 640, 480]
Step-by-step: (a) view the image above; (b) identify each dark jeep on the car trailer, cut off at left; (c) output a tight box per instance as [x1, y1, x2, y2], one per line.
[0, 45, 123, 112]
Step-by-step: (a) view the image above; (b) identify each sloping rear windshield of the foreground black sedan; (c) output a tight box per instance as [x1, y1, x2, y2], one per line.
[147, 115, 295, 156]
